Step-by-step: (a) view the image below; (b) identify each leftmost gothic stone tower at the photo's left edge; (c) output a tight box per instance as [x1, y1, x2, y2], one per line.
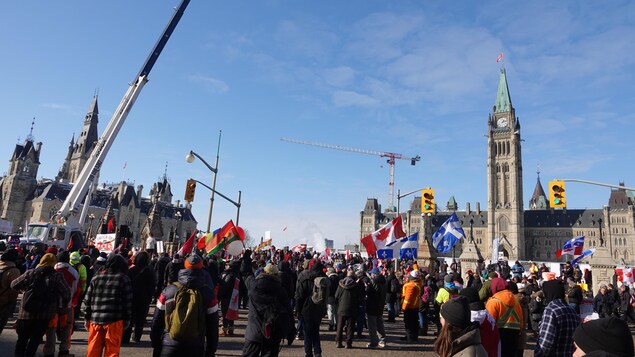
[0, 127, 42, 231]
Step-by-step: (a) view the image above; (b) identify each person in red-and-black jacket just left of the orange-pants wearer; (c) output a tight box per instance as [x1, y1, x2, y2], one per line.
[43, 251, 81, 357]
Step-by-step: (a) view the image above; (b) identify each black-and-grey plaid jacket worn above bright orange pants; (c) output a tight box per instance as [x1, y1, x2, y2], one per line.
[82, 272, 132, 325]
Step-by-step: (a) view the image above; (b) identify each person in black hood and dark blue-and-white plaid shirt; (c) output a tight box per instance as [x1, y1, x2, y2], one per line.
[534, 280, 580, 357]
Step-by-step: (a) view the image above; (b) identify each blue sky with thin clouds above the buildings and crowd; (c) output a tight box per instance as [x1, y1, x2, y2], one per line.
[0, 0, 635, 247]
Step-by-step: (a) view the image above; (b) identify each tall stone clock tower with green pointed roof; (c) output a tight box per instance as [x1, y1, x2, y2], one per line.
[487, 68, 525, 261]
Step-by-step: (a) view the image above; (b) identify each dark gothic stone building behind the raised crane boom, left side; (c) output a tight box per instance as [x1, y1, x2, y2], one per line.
[0, 96, 197, 246]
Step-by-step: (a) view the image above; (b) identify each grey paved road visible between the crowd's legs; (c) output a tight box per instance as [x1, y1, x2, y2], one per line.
[0, 310, 533, 357]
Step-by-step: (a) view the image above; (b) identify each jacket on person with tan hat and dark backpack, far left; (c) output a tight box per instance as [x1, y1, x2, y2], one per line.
[11, 267, 71, 320]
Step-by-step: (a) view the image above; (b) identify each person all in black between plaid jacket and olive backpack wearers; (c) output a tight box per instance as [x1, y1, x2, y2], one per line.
[122, 251, 156, 344]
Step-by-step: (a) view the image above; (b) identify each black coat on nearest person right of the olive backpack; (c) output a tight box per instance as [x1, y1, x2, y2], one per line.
[241, 258, 293, 343]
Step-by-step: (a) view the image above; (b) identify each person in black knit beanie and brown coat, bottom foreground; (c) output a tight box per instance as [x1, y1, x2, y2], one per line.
[434, 296, 490, 357]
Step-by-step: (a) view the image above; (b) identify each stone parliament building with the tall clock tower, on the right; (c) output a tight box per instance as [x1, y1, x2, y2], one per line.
[360, 69, 635, 286]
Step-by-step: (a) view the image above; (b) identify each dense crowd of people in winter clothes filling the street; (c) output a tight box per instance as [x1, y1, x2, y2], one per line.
[0, 239, 635, 357]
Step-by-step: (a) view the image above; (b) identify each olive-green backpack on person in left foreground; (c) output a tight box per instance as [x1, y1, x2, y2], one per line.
[165, 282, 206, 342]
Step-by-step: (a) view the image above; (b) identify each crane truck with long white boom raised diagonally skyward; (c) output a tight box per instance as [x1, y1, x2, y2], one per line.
[20, 0, 190, 251]
